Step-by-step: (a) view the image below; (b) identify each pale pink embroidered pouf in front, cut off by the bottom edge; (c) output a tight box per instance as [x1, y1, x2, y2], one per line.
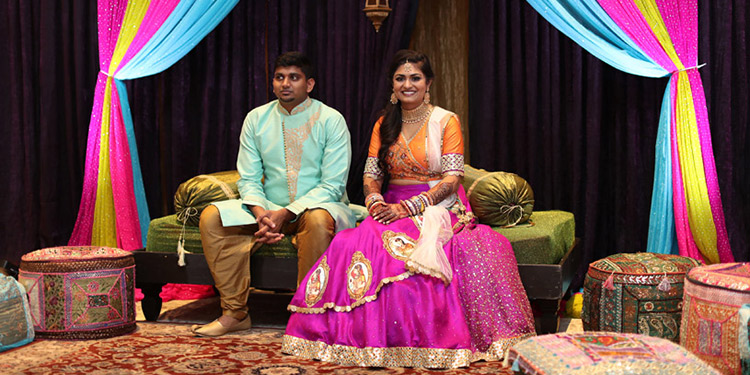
[507, 332, 719, 375]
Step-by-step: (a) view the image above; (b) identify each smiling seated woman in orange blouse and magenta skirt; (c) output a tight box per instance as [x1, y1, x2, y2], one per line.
[282, 50, 534, 368]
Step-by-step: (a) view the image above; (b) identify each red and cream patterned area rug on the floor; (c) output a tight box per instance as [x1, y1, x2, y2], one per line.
[0, 322, 512, 375]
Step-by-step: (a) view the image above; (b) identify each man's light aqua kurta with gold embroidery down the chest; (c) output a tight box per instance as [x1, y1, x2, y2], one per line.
[214, 98, 355, 232]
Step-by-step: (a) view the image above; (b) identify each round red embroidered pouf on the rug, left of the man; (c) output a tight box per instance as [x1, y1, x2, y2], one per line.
[18, 246, 136, 339]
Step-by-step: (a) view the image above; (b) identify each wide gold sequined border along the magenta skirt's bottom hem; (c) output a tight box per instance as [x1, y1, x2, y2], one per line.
[281, 333, 534, 368]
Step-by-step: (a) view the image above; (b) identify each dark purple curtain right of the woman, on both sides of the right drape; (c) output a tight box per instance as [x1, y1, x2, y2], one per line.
[469, 0, 750, 278]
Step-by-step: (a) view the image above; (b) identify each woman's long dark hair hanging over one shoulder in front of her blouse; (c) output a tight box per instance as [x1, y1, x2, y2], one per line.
[378, 49, 435, 191]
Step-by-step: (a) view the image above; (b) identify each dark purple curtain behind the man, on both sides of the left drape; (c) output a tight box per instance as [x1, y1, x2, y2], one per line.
[0, 0, 418, 263]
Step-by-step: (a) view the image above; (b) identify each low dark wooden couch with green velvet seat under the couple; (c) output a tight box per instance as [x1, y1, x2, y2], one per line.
[134, 169, 581, 333]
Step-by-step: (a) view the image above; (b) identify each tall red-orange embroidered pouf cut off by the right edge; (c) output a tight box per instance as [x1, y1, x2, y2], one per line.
[680, 263, 750, 374]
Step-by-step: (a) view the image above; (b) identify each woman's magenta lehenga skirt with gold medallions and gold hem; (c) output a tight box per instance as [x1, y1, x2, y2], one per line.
[282, 185, 535, 368]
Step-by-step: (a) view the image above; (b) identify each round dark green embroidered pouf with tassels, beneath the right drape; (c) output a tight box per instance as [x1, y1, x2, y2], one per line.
[581, 253, 700, 342]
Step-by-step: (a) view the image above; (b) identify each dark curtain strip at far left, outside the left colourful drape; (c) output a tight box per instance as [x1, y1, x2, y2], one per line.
[0, 0, 99, 262]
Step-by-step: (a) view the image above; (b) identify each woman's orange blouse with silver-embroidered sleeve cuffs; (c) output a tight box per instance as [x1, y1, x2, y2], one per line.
[364, 115, 464, 182]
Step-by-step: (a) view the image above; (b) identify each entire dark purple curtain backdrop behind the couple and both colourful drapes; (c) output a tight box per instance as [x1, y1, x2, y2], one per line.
[0, 0, 750, 270]
